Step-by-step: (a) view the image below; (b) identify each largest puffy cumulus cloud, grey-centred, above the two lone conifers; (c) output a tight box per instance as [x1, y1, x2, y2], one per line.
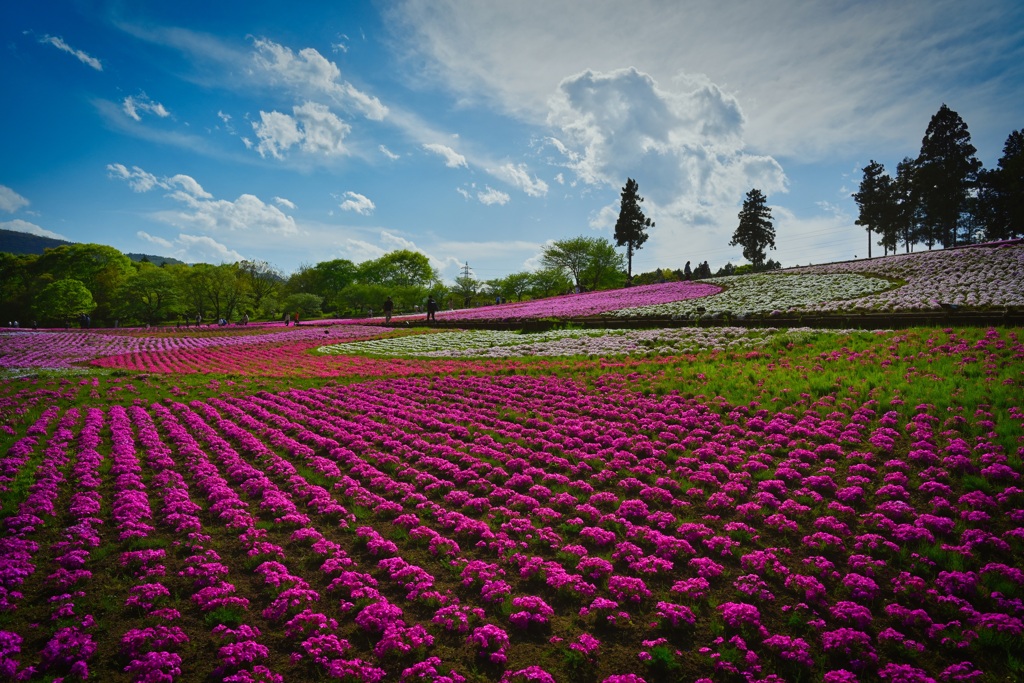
[548, 69, 785, 222]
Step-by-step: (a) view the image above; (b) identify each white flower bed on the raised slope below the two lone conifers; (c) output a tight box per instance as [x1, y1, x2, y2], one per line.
[613, 272, 893, 317]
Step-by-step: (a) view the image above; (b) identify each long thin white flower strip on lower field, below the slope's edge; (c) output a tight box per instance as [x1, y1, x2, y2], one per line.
[319, 327, 869, 358]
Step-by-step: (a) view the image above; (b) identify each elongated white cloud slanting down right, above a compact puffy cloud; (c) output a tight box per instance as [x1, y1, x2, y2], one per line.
[253, 38, 387, 121]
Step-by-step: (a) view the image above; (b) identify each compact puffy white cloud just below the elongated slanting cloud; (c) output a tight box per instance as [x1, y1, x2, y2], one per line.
[252, 101, 351, 159]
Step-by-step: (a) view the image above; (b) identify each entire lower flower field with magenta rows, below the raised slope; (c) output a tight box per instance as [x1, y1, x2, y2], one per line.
[0, 326, 1024, 683]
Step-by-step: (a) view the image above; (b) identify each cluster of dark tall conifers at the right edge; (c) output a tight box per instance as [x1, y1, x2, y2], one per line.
[853, 104, 1024, 258]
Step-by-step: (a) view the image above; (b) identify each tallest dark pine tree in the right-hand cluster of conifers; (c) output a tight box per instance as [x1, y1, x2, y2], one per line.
[914, 104, 981, 249]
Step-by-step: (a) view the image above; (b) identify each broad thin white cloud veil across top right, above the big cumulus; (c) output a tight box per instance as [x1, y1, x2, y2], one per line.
[387, 0, 1024, 159]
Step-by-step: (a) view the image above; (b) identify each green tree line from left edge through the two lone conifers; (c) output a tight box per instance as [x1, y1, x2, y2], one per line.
[0, 178, 780, 327]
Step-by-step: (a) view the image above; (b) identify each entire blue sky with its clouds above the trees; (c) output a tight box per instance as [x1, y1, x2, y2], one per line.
[0, 0, 1024, 282]
